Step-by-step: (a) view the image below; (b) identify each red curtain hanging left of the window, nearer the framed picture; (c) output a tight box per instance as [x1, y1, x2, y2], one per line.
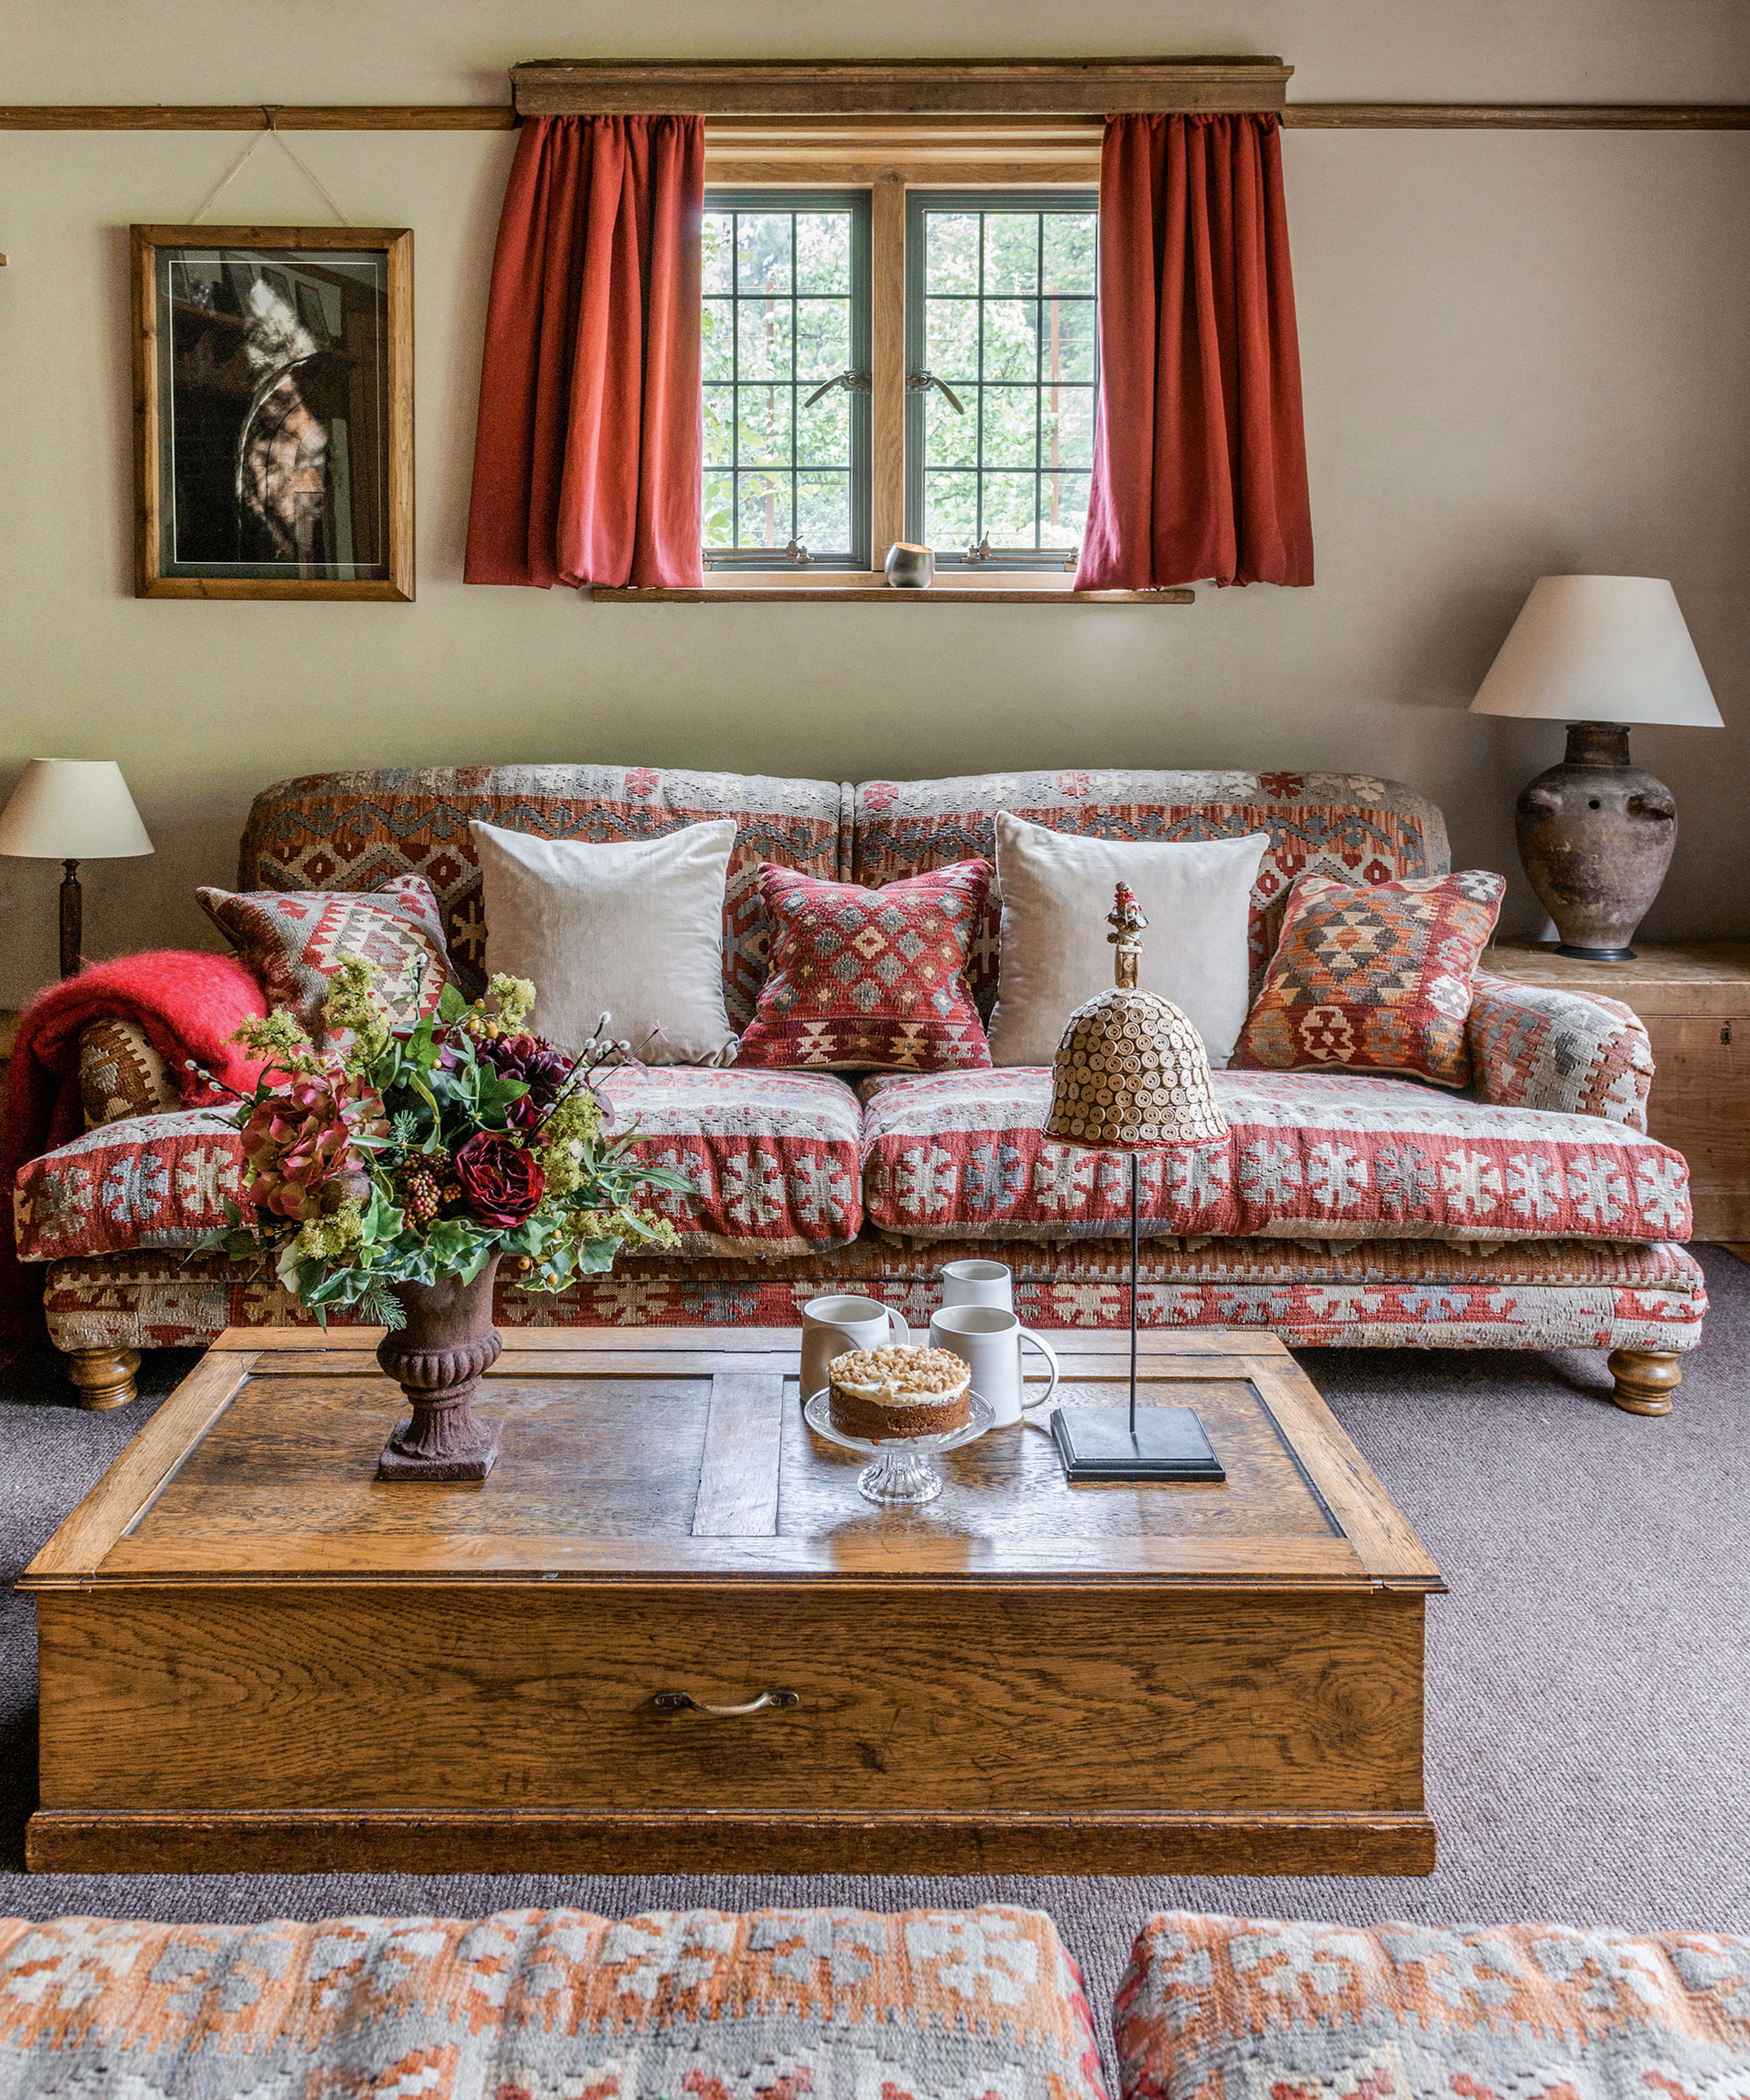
[465, 117, 704, 590]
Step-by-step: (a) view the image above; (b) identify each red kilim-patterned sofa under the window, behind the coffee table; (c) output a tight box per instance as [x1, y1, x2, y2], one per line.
[15, 766, 1706, 1411]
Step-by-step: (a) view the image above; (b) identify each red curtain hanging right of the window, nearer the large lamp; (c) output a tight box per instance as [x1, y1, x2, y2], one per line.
[1075, 116, 1313, 590]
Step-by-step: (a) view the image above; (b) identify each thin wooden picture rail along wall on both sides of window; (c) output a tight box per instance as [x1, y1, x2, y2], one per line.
[0, 103, 1750, 133]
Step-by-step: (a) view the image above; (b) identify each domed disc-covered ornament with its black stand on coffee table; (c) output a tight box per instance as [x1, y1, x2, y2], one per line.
[1044, 882, 1227, 1482]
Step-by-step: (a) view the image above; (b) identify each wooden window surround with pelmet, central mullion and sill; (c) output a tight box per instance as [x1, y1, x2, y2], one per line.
[510, 59, 1292, 605]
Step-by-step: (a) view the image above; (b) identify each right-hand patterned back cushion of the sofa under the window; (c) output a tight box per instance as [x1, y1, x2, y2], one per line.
[849, 773, 1452, 1014]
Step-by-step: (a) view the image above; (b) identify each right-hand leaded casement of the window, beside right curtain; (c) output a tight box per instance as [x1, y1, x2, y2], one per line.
[906, 191, 1099, 567]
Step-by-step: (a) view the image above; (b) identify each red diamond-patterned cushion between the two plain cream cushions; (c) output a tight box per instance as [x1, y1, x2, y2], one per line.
[735, 861, 996, 1071]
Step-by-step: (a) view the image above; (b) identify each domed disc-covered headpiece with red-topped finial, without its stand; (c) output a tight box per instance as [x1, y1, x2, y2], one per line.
[1044, 882, 1227, 1151]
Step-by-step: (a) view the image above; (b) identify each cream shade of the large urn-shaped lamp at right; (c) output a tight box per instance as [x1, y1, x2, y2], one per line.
[1471, 576, 1723, 729]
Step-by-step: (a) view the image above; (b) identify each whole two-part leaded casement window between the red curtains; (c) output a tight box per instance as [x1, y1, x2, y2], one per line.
[702, 185, 1099, 573]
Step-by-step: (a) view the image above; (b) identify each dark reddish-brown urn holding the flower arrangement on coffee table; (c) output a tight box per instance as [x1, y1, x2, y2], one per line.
[376, 1254, 504, 1480]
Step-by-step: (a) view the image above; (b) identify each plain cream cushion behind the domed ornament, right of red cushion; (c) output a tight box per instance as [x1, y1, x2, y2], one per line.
[990, 810, 1269, 1067]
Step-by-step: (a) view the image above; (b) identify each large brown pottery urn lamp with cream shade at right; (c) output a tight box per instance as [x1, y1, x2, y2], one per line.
[1471, 576, 1723, 962]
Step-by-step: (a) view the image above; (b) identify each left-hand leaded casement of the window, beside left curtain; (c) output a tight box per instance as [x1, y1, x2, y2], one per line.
[702, 191, 870, 569]
